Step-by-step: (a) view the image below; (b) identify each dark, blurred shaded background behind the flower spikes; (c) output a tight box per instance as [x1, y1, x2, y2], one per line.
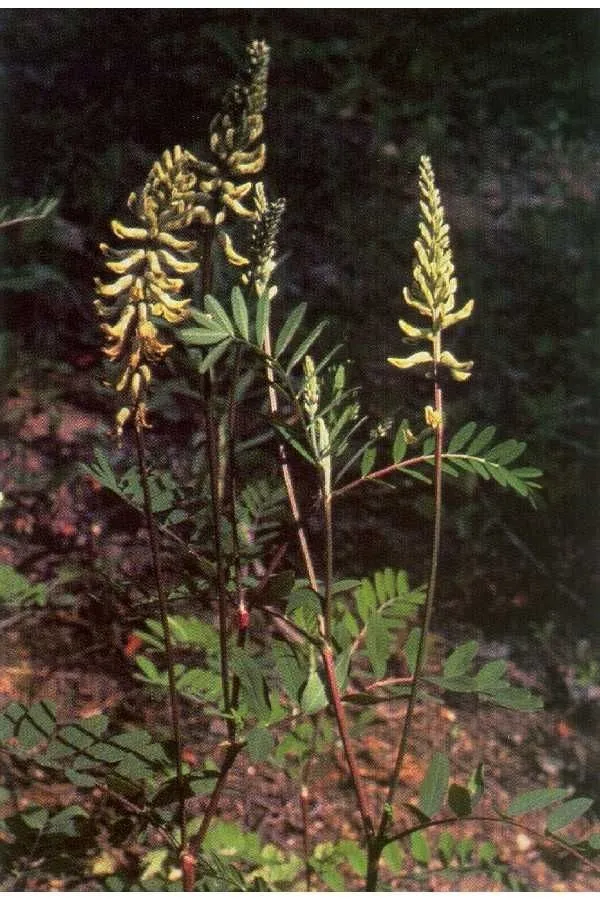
[0, 9, 600, 630]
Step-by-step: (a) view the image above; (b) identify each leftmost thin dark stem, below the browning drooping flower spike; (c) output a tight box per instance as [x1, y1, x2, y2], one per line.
[134, 424, 187, 853]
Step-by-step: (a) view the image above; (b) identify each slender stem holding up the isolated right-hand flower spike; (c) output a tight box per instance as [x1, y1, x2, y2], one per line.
[366, 381, 444, 891]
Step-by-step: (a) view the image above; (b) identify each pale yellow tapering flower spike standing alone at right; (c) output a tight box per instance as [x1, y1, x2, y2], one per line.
[388, 156, 475, 381]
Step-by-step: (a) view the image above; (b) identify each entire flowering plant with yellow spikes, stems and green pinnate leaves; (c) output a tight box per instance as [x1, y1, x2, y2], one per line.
[0, 33, 597, 891]
